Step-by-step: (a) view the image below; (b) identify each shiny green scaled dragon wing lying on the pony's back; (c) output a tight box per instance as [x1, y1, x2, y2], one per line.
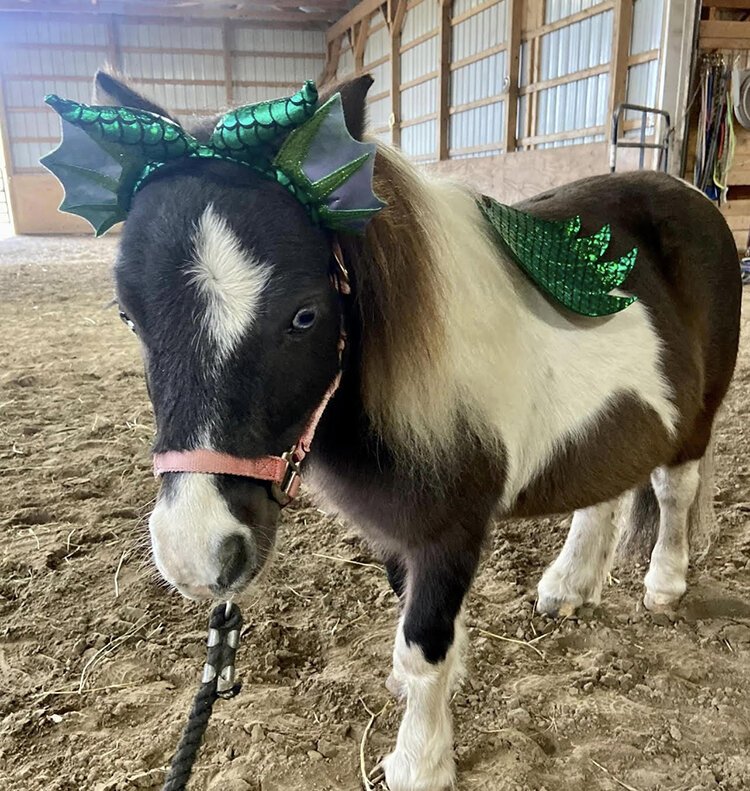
[479, 197, 638, 317]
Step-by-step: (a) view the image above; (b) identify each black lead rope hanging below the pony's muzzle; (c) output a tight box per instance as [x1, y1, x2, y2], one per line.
[162, 602, 242, 791]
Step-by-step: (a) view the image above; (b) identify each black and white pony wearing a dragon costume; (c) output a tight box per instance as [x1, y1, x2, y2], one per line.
[97, 75, 741, 791]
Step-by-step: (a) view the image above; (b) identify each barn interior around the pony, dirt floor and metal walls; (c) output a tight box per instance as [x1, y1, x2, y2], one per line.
[0, 0, 750, 791]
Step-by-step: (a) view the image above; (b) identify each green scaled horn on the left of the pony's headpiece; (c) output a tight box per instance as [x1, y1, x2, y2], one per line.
[44, 95, 199, 162]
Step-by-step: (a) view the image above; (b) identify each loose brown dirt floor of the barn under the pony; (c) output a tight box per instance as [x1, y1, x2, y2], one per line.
[0, 238, 750, 791]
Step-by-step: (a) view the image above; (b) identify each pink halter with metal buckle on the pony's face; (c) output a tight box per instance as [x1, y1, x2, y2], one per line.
[154, 239, 351, 507]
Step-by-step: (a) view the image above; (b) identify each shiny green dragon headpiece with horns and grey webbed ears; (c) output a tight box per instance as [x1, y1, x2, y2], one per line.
[41, 81, 384, 236]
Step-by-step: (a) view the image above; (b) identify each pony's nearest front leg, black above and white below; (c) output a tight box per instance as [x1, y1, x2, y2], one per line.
[383, 547, 479, 791]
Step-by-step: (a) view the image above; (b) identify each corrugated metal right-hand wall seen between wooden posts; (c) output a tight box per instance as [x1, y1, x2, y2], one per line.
[328, 0, 666, 162]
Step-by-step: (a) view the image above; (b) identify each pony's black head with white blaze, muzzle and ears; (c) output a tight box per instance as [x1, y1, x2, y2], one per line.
[97, 74, 371, 598]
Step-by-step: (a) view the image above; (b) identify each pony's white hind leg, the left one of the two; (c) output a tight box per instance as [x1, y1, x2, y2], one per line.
[536, 500, 618, 616]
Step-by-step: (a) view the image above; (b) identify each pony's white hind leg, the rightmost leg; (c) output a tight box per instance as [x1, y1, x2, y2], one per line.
[643, 461, 700, 610]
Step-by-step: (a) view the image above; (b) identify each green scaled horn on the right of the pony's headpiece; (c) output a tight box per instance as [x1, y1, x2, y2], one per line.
[209, 80, 318, 159]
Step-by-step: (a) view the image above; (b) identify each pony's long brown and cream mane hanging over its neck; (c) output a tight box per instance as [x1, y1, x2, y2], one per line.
[354, 145, 516, 464]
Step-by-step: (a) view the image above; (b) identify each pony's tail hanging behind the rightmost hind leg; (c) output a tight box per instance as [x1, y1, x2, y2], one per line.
[617, 432, 718, 563]
